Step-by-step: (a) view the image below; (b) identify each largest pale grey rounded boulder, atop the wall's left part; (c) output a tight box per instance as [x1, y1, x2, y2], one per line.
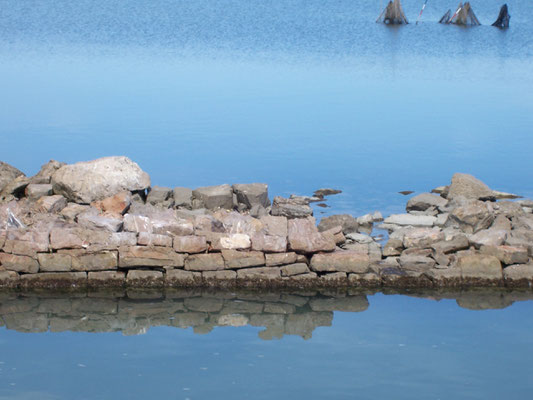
[51, 157, 150, 204]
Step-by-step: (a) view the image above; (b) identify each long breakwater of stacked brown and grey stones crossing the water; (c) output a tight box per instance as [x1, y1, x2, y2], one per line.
[0, 157, 533, 289]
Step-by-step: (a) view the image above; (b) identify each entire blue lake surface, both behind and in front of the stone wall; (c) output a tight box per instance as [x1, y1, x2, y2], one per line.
[0, 0, 533, 399]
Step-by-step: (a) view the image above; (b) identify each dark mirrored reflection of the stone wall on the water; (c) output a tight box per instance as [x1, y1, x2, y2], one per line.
[0, 289, 533, 340]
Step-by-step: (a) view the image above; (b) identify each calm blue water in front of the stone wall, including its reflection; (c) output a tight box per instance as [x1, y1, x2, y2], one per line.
[0, 292, 533, 400]
